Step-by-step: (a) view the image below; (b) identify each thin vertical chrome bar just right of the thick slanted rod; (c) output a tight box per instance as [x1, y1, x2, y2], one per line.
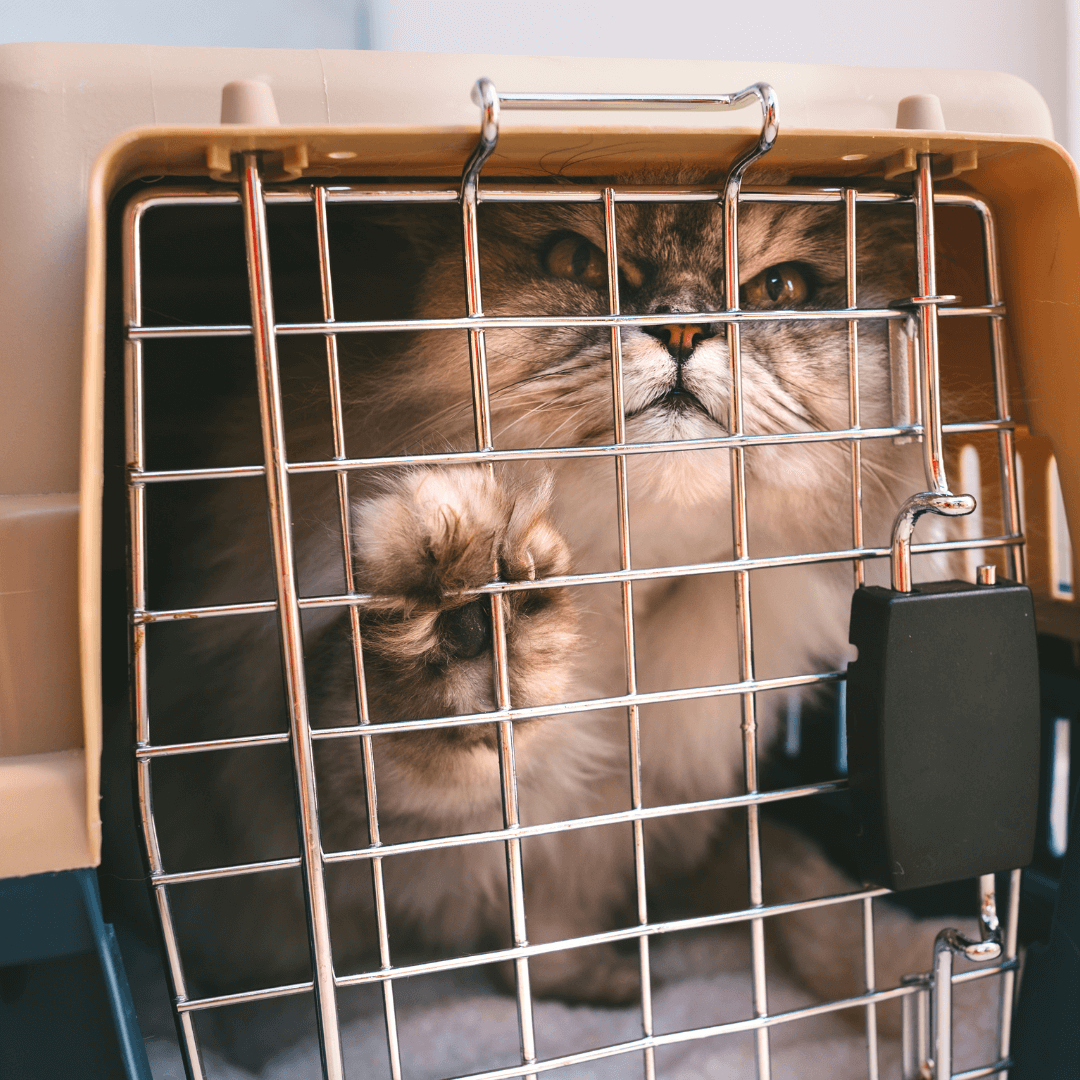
[313, 187, 402, 1080]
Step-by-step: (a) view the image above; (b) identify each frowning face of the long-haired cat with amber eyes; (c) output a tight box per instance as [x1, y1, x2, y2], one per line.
[408, 195, 913, 502]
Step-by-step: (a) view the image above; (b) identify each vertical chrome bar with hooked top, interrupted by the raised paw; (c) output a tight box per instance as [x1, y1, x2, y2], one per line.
[461, 79, 537, 1080]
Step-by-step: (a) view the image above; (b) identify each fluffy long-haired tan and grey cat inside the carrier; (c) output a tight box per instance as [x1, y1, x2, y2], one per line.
[135, 178, 980, 1028]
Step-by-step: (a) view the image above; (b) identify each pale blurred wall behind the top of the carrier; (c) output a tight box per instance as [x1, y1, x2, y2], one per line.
[0, 0, 1080, 153]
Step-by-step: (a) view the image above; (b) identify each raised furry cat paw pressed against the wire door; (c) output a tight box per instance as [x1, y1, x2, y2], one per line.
[353, 467, 577, 713]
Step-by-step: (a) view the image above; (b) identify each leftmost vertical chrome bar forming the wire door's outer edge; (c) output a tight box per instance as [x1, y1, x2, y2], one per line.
[121, 198, 205, 1080]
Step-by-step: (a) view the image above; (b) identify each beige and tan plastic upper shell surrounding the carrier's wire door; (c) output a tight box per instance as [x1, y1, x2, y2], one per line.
[0, 38, 1080, 1075]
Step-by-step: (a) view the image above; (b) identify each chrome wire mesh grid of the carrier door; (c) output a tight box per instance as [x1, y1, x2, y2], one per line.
[123, 84, 1024, 1080]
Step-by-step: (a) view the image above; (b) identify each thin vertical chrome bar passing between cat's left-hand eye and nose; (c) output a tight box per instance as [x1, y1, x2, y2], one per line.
[604, 189, 657, 1080]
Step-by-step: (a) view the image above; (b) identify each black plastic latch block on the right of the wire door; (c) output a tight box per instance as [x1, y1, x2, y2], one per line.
[847, 580, 1040, 890]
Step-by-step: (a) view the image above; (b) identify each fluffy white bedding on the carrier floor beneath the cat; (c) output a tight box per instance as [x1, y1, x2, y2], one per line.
[133, 930, 998, 1080]
